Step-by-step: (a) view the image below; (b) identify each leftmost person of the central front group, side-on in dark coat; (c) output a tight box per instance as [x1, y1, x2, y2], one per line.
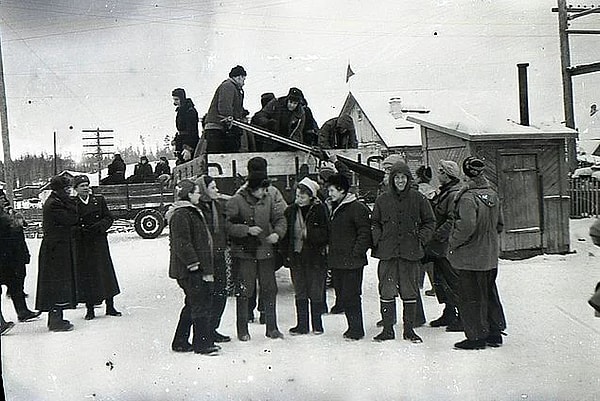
[166, 179, 220, 355]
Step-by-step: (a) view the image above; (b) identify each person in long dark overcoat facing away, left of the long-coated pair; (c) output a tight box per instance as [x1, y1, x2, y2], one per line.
[35, 176, 79, 331]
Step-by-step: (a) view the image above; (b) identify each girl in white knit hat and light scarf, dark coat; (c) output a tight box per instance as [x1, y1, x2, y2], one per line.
[281, 177, 329, 335]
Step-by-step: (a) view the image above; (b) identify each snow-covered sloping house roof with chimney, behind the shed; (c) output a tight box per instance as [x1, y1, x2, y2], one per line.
[348, 92, 421, 148]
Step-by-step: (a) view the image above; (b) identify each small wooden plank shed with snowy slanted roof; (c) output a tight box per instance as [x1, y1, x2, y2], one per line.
[408, 116, 577, 258]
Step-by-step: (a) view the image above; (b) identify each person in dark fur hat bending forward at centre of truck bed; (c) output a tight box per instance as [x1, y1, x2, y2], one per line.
[253, 88, 306, 152]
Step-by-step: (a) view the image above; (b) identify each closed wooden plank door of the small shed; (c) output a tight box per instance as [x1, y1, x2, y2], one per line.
[498, 153, 543, 252]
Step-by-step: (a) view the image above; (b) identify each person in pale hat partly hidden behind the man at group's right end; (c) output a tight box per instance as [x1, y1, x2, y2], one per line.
[423, 160, 462, 331]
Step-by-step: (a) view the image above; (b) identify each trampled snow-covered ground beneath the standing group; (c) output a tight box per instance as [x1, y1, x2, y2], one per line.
[2, 220, 600, 401]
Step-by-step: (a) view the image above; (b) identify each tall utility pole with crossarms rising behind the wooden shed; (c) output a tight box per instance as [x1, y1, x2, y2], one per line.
[552, 0, 600, 171]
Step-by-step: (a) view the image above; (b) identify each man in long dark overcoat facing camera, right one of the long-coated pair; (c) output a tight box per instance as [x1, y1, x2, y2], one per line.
[73, 175, 121, 320]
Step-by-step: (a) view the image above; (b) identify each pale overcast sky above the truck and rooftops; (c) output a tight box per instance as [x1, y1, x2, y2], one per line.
[0, 0, 600, 162]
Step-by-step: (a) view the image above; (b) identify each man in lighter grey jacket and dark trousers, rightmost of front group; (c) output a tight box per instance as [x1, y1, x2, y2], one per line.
[448, 156, 506, 349]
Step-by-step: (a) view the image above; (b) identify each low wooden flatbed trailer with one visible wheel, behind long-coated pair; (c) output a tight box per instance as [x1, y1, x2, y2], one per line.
[92, 182, 174, 239]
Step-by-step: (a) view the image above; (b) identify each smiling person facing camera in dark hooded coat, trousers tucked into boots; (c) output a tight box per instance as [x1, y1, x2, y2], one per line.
[372, 162, 435, 342]
